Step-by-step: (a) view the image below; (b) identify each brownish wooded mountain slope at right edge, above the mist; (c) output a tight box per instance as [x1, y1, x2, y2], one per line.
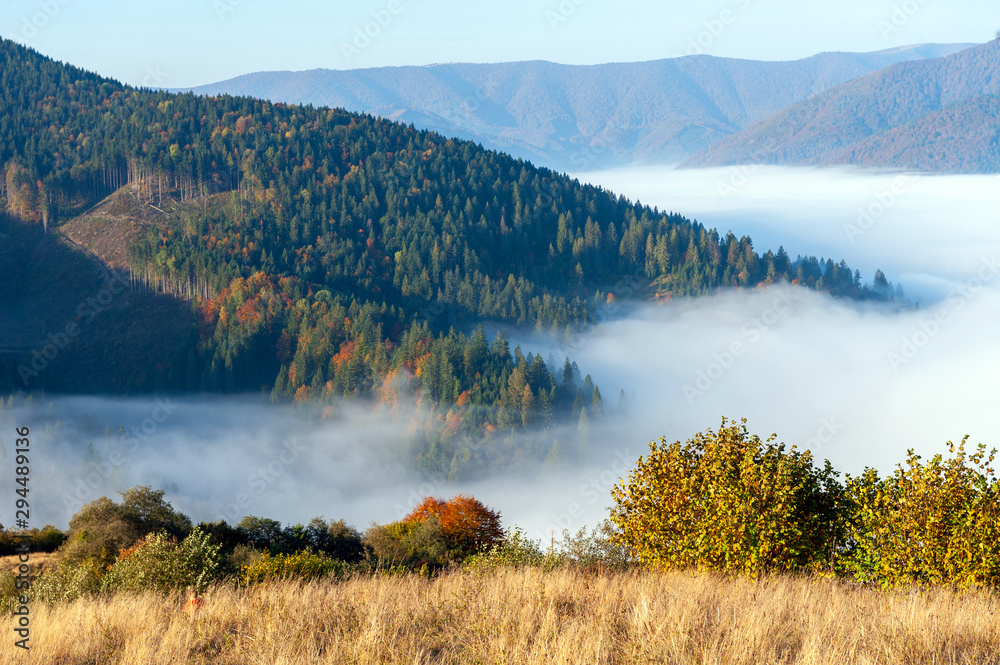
[682, 40, 1000, 172]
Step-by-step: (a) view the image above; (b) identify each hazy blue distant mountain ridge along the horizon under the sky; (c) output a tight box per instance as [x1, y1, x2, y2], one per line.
[185, 44, 969, 171]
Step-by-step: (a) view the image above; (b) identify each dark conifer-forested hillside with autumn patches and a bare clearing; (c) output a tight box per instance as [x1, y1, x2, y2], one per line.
[0, 41, 887, 416]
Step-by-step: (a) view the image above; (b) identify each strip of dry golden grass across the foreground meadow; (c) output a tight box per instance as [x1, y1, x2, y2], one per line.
[0, 570, 1000, 665]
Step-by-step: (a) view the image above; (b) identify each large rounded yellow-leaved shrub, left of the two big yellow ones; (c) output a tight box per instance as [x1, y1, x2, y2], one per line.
[611, 419, 843, 573]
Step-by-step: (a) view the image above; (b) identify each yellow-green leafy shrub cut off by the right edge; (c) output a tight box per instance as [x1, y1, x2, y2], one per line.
[844, 437, 1000, 587]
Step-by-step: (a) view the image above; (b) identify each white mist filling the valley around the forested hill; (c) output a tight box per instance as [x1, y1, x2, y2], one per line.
[0, 167, 1000, 542]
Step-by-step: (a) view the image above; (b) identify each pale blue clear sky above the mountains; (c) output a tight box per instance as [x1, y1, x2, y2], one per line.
[0, 0, 1000, 87]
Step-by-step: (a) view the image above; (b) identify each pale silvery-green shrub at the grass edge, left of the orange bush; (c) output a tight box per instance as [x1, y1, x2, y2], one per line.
[101, 528, 221, 592]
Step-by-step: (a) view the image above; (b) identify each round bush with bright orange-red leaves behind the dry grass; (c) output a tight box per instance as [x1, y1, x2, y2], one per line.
[403, 494, 503, 558]
